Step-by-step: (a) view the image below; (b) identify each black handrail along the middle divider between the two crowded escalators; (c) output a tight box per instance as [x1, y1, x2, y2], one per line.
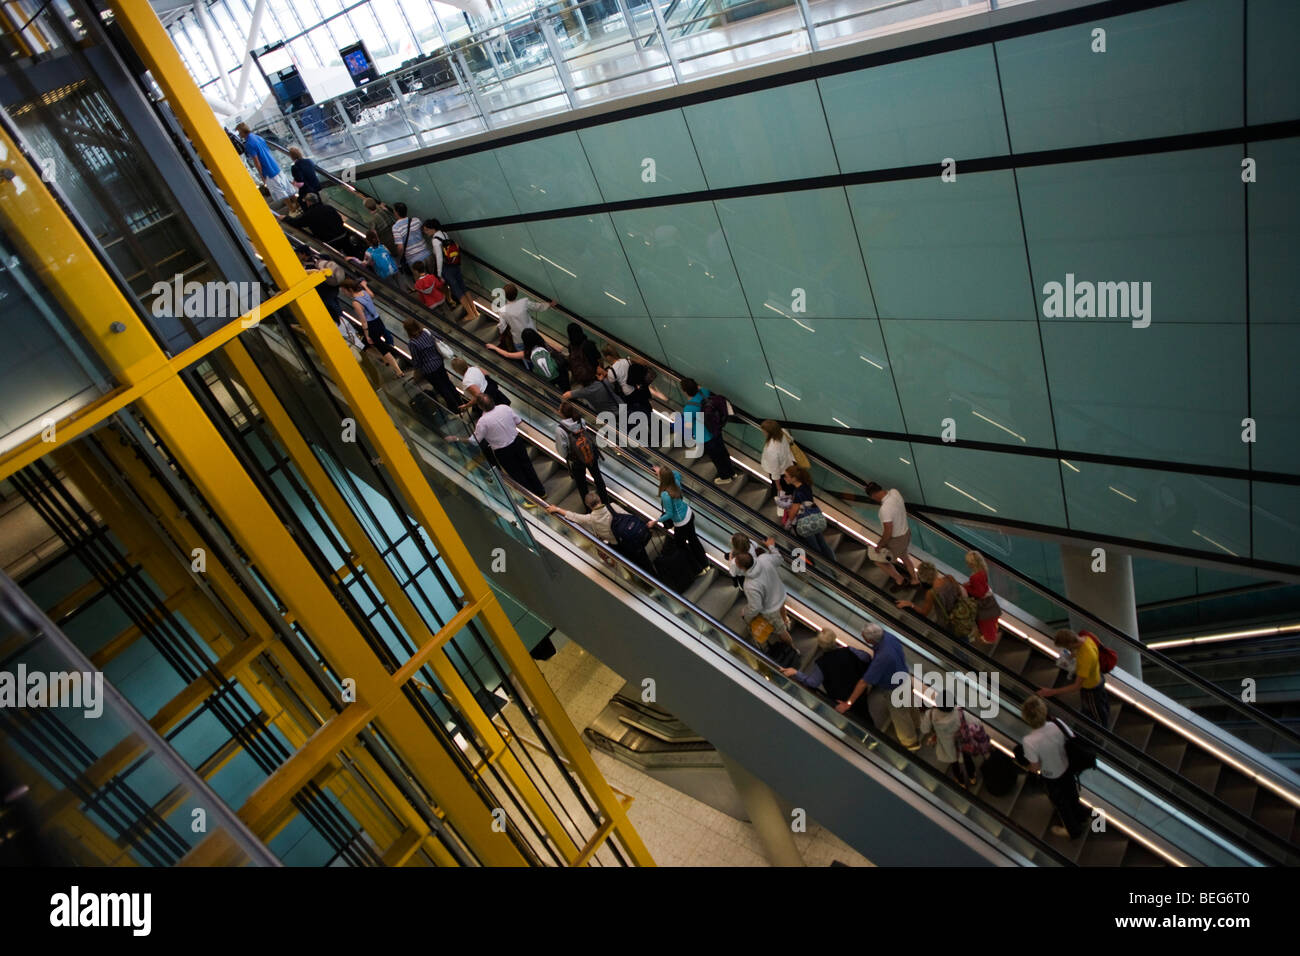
[274, 217, 1295, 858]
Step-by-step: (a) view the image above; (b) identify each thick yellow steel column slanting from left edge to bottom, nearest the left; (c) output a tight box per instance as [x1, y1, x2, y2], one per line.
[0, 117, 527, 866]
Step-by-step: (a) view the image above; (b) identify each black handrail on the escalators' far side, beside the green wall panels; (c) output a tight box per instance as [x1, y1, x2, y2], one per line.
[287, 155, 1300, 747]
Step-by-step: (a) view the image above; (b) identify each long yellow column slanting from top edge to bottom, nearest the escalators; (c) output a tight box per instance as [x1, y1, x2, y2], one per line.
[109, 0, 654, 865]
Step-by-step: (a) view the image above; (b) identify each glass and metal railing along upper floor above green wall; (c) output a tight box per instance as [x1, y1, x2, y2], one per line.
[256, 0, 1003, 164]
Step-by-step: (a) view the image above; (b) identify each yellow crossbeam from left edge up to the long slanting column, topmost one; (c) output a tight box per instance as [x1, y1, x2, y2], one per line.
[0, 277, 325, 480]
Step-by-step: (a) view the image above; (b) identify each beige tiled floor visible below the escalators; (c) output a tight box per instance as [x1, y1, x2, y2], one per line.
[541, 635, 871, 866]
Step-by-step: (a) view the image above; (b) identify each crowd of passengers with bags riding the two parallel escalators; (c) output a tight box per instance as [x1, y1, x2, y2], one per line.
[276, 175, 1109, 838]
